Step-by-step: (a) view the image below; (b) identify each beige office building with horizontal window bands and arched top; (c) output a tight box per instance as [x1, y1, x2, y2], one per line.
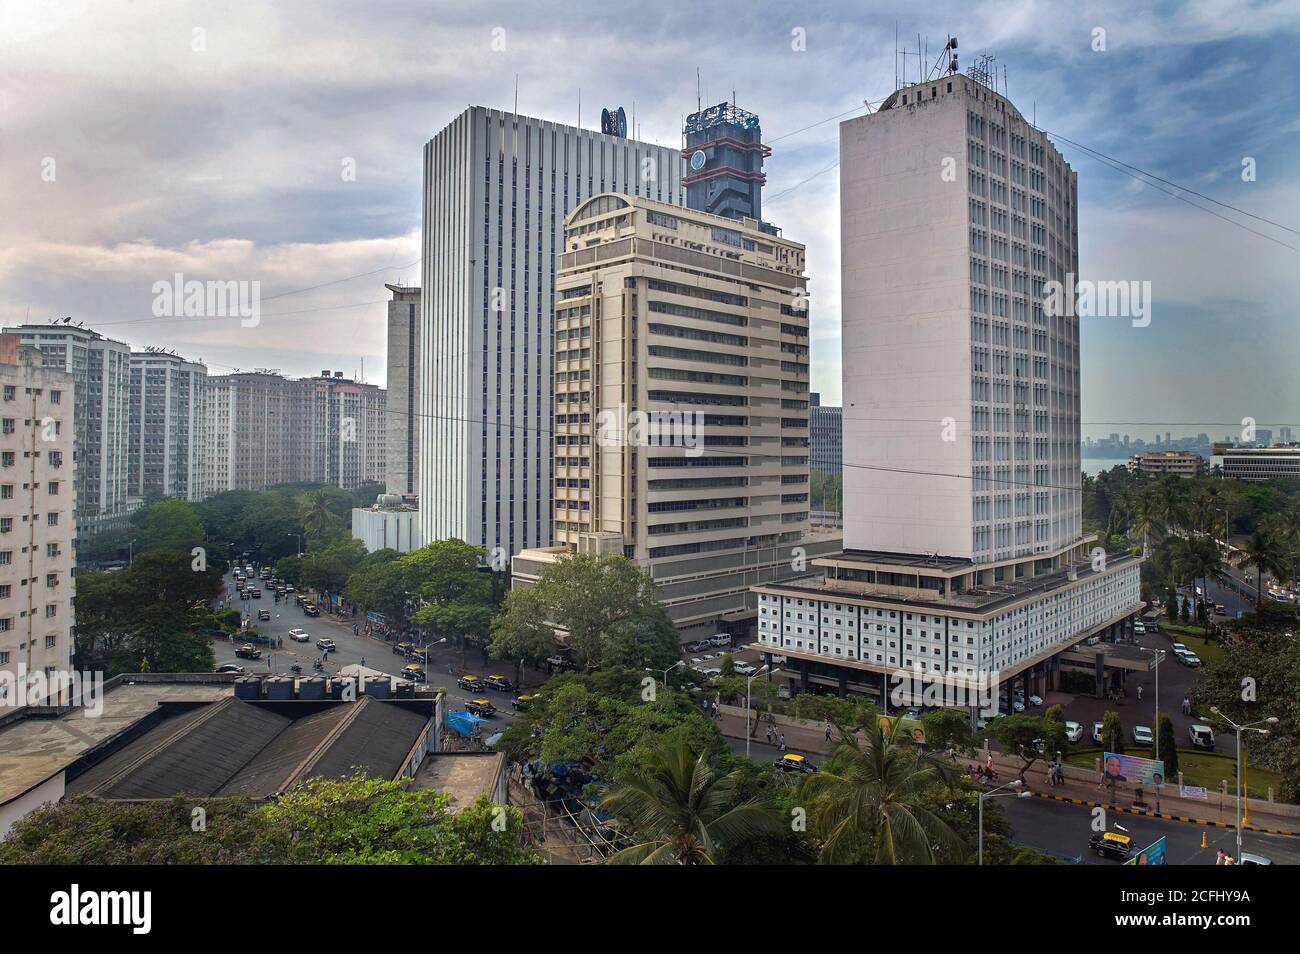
[515, 194, 839, 630]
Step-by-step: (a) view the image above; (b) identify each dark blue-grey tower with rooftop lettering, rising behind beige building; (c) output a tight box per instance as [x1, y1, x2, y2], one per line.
[681, 103, 772, 227]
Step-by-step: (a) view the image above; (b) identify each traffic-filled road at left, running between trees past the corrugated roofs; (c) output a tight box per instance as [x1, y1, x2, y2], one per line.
[212, 574, 525, 729]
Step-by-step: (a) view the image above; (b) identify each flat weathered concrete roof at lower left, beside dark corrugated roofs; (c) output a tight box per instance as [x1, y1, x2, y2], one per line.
[0, 680, 233, 805]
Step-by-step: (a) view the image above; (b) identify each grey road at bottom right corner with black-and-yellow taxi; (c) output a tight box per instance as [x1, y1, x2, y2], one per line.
[997, 798, 1300, 864]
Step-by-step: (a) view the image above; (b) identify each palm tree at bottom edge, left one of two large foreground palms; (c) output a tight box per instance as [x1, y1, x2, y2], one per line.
[601, 740, 787, 864]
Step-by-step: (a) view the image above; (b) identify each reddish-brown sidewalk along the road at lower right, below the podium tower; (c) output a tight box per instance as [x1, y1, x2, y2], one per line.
[718, 712, 1300, 834]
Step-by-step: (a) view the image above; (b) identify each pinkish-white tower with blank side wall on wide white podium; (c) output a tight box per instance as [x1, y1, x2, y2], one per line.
[758, 70, 1143, 711]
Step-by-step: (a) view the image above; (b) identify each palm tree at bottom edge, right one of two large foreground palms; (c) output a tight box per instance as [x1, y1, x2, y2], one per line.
[800, 719, 963, 864]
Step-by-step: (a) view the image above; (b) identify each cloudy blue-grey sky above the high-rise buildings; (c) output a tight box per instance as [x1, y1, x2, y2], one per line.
[0, 0, 1300, 439]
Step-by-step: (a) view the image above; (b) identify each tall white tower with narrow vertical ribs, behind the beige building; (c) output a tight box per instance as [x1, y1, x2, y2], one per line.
[417, 107, 684, 554]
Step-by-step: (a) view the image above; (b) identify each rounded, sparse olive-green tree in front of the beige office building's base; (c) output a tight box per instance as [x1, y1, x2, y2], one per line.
[493, 554, 658, 669]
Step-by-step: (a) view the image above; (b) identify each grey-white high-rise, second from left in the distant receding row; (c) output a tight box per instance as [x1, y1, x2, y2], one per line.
[127, 348, 208, 500]
